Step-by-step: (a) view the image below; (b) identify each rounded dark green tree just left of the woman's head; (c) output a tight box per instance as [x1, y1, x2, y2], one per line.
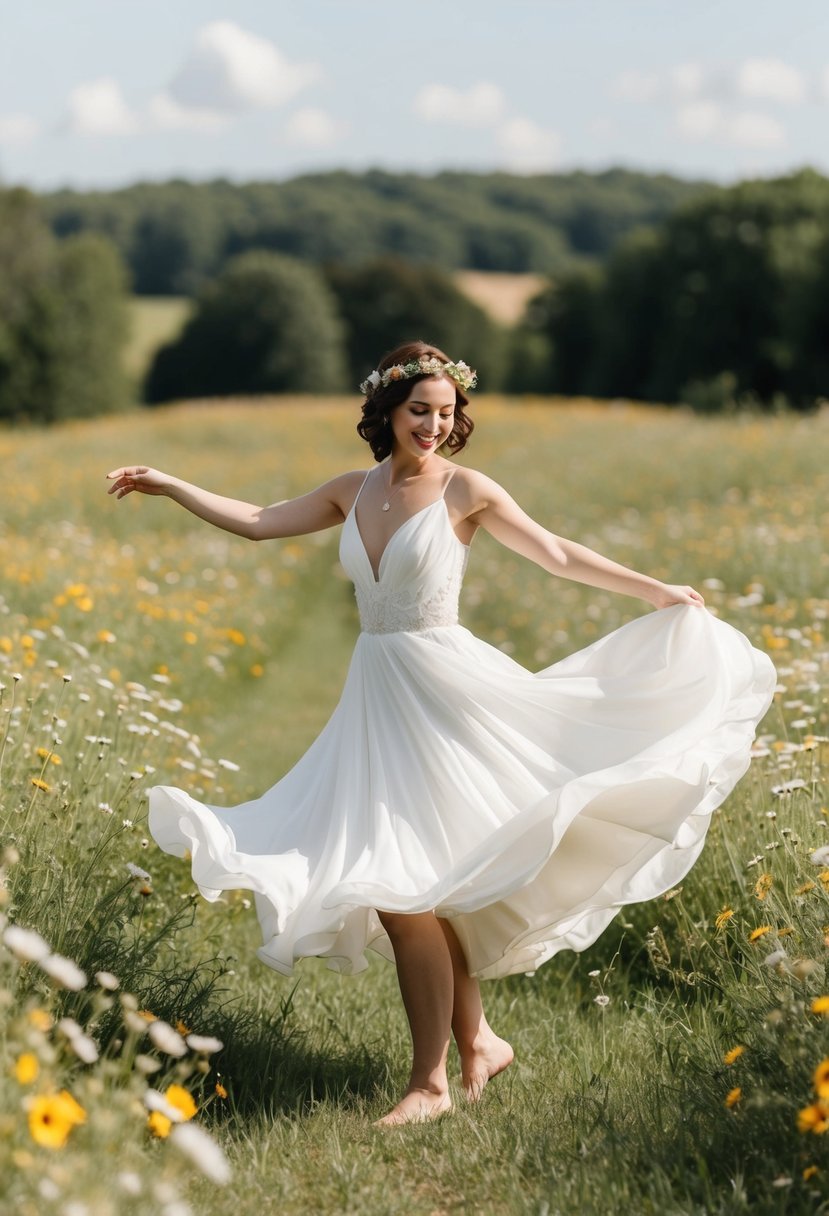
[145, 252, 348, 404]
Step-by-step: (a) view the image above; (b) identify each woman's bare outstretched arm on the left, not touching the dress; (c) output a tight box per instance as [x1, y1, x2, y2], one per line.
[107, 465, 365, 540]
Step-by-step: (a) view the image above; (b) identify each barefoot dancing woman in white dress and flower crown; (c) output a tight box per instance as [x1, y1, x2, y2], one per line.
[108, 342, 774, 1125]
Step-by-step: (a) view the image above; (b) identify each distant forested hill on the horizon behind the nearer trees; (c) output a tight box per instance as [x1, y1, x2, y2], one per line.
[40, 169, 716, 295]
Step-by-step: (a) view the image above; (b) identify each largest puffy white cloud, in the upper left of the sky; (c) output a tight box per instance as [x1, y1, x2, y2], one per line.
[169, 21, 321, 113]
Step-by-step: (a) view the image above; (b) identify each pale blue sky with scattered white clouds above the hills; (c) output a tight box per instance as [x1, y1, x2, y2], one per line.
[0, 0, 829, 190]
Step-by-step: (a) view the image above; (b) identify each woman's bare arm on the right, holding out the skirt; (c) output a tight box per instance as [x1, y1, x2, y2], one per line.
[464, 473, 704, 608]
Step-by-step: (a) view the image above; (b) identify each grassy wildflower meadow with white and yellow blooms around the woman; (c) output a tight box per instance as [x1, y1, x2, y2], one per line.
[0, 398, 829, 1216]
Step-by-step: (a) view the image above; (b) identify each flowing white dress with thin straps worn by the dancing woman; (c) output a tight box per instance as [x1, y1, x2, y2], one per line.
[150, 471, 776, 979]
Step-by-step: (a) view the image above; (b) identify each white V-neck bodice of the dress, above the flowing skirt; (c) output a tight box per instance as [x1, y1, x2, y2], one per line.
[339, 497, 469, 634]
